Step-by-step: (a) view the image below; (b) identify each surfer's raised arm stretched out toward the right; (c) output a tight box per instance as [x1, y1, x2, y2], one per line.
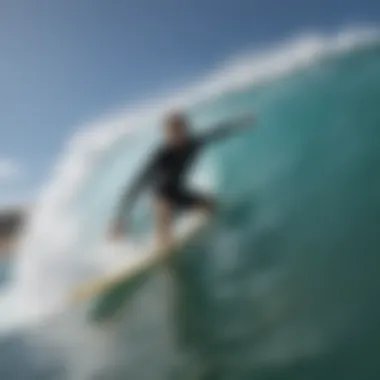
[201, 114, 255, 143]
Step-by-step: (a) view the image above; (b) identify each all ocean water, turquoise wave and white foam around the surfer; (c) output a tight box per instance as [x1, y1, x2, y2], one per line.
[0, 32, 380, 380]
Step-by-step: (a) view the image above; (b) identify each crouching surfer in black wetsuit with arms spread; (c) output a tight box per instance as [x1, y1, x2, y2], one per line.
[111, 112, 254, 245]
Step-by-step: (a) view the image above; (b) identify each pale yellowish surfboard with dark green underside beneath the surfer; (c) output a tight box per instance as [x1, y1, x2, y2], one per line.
[69, 213, 209, 321]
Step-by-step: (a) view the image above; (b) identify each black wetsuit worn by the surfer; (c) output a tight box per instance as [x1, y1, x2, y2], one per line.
[119, 124, 238, 215]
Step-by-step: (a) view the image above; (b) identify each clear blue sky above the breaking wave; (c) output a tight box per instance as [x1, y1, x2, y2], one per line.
[0, 0, 380, 202]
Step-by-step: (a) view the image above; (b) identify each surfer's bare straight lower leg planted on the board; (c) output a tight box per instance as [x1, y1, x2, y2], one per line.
[155, 198, 173, 247]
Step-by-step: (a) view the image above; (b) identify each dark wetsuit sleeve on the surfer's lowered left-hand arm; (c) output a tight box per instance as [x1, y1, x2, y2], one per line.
[118, 154, 158, 219]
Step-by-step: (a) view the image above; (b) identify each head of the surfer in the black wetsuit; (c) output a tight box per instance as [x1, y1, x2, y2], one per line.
[164, 112, 190, 146]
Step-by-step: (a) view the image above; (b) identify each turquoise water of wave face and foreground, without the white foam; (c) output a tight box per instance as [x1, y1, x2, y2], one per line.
[0, 39, 380, 380]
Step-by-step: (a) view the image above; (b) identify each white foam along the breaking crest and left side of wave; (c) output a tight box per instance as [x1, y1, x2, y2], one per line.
[1, 28, 379, 330]
